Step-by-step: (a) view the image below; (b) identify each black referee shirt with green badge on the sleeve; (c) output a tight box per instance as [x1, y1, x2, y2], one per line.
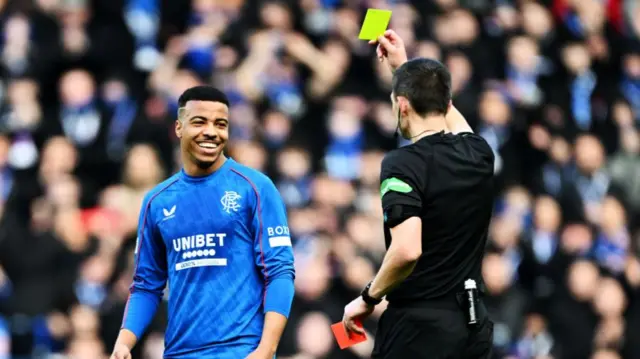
[380, 132, 494, 305]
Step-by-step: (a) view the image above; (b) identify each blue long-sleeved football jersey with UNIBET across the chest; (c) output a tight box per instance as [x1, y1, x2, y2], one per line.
[123, 158, 295, 359]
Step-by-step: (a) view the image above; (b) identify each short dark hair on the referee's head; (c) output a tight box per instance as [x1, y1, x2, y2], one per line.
[392, 58, 451, 117]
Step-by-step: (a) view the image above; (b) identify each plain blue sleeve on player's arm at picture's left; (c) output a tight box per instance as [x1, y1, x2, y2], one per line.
[122, 194, 167, 338]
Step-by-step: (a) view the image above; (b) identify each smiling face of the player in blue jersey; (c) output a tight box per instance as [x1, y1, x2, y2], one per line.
[176, 101, 229, 170]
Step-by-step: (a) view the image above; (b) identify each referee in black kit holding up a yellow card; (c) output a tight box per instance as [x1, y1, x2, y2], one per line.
[343, 30, 494, 359]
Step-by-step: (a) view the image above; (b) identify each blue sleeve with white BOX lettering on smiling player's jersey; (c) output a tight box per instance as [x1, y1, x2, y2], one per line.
[253, 179, 295, 317]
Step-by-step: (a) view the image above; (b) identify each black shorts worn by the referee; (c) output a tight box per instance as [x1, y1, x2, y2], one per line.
[372, 300, 493, 359]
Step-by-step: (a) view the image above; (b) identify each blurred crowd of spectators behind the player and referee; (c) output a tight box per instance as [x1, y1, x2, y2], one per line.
[0, 0, 640, 359]
